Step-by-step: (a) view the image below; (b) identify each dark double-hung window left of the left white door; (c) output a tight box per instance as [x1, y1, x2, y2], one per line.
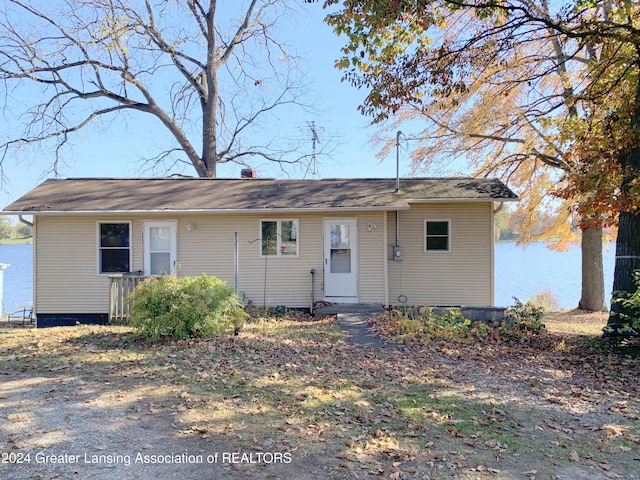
[98, 222, 131, 273]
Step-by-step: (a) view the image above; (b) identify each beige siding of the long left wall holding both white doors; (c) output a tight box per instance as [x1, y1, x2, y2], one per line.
[34, 212, 404, 314]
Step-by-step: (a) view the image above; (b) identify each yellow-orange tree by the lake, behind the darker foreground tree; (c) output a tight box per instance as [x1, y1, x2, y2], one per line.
[324, 0, 616, 310]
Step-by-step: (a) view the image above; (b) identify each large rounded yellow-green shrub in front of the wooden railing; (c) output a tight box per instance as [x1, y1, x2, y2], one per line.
[127, 274, 247, 340]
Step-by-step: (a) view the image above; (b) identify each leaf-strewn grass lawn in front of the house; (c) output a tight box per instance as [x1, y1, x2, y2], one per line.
[0, 314, 640, 480]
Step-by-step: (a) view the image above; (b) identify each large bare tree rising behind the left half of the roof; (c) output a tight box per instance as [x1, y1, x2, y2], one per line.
[0, 0, 318, 177]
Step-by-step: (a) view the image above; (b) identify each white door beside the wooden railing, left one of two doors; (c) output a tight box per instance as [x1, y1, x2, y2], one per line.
[144, 221, 178, 275]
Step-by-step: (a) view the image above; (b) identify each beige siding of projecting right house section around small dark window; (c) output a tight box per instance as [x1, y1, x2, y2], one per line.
[387, 203, 493, 306]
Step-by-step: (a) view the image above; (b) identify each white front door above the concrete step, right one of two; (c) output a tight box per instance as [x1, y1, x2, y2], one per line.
[324, 218, 358, 303]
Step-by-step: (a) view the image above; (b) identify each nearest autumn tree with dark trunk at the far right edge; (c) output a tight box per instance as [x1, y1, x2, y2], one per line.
[326, 0, 640, 321]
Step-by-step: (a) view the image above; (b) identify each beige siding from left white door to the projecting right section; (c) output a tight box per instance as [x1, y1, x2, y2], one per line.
[178, 212, 385, 308]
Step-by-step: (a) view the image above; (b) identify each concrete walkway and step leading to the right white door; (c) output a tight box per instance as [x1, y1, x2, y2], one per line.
[314, 303, 399, 348]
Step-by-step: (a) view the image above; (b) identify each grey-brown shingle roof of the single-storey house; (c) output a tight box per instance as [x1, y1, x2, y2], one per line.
[4, 178, 518, 213]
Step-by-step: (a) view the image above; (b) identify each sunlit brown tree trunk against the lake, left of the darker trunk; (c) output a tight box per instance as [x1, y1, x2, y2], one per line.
[578, 226, 606, 312]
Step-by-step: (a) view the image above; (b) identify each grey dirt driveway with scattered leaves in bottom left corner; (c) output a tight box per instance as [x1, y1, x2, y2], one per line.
[0, 328, 322, 480]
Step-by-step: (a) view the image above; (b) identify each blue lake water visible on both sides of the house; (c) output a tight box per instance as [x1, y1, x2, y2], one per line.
[0, 243, 615, 312]
